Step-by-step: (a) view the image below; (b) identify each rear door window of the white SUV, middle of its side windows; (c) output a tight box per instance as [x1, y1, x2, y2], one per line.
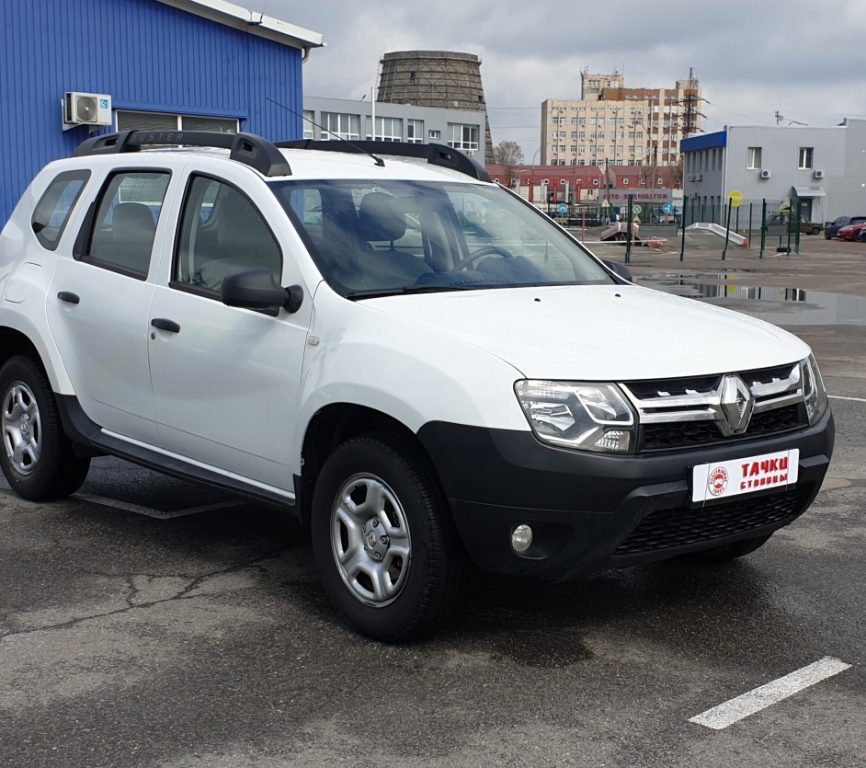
[82, 171, 170, 279]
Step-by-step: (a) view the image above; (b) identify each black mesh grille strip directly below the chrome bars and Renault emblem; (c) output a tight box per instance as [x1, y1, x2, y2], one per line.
[638, 405, 808, 451]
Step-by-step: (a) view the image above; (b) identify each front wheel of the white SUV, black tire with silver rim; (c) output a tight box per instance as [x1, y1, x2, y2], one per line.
[311, 435, 462, 642]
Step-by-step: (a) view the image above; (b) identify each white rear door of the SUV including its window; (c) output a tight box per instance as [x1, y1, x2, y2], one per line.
[47, 168, 171, 443]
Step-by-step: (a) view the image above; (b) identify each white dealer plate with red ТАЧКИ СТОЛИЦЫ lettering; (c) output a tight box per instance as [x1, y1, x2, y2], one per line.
[692, 448, 800, 501]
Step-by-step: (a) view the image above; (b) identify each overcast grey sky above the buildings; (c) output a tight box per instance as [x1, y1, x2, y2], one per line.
[262, 0, 866, 161]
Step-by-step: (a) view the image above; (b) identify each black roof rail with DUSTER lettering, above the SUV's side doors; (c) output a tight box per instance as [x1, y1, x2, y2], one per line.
[74, 131, 292, 176]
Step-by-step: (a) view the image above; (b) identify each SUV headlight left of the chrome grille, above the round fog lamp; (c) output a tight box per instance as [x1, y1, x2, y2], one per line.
[514, 381, 635, 453]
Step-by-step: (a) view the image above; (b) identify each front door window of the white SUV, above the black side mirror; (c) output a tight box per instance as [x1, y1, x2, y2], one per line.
[172, 175, 283, 294]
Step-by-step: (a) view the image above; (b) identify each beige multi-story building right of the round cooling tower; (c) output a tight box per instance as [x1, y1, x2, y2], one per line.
[541, 70, 703, 166]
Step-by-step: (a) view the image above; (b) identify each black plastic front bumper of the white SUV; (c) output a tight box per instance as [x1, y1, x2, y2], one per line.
[418, 407, 835, 580]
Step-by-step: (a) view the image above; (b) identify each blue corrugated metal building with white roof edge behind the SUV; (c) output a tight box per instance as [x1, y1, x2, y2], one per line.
[0, 0, 322, 222]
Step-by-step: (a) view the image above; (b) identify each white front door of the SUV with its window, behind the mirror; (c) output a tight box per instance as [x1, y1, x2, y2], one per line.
[149, 171, 312, 493]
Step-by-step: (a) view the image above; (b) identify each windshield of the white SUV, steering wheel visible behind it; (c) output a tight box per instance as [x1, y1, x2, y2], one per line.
[271, 180, 614, 298]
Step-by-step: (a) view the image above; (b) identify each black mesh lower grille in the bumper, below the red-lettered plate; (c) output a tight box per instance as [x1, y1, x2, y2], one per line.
[613, 489, 807, 557]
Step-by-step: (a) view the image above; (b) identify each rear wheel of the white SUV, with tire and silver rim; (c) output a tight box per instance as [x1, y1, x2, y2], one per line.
[0, 355, 90, 501]
